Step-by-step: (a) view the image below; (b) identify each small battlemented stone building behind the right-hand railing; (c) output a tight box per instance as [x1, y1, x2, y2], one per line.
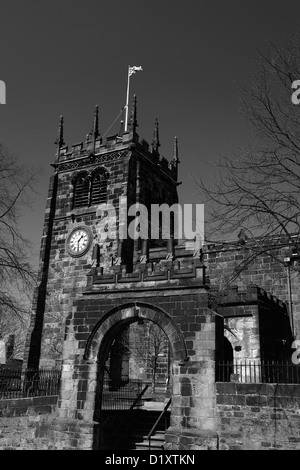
[217, 286, 293, 361]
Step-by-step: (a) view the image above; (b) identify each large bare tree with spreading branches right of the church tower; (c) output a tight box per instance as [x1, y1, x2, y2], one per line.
[196, 35, 300, 298]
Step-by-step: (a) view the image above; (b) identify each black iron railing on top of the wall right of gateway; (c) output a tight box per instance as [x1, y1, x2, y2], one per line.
[216, 360, 300, 384]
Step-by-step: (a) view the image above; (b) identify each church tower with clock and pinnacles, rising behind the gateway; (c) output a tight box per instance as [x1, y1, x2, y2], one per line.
[25, 96, 178, 367]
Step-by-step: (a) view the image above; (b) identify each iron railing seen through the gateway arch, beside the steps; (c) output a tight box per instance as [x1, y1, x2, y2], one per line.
[101, 377, 144, 410]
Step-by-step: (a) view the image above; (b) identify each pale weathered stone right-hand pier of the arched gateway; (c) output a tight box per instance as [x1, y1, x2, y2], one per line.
[165, 309, 217, 450]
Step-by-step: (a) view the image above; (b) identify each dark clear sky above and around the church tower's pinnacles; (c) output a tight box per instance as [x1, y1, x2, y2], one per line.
[0, 0, 300, 262]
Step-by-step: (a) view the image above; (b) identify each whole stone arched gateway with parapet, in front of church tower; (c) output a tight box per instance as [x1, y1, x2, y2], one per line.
[59, 274, 223, 449]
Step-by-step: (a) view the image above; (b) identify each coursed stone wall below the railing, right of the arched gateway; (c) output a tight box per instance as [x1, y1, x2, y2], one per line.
[216, 382, 300, 450]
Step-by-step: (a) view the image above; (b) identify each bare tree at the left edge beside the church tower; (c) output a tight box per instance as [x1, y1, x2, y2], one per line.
[0, 144, 36, 356]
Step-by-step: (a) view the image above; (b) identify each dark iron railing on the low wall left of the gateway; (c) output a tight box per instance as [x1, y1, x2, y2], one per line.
[0, 368, 60, 399]
